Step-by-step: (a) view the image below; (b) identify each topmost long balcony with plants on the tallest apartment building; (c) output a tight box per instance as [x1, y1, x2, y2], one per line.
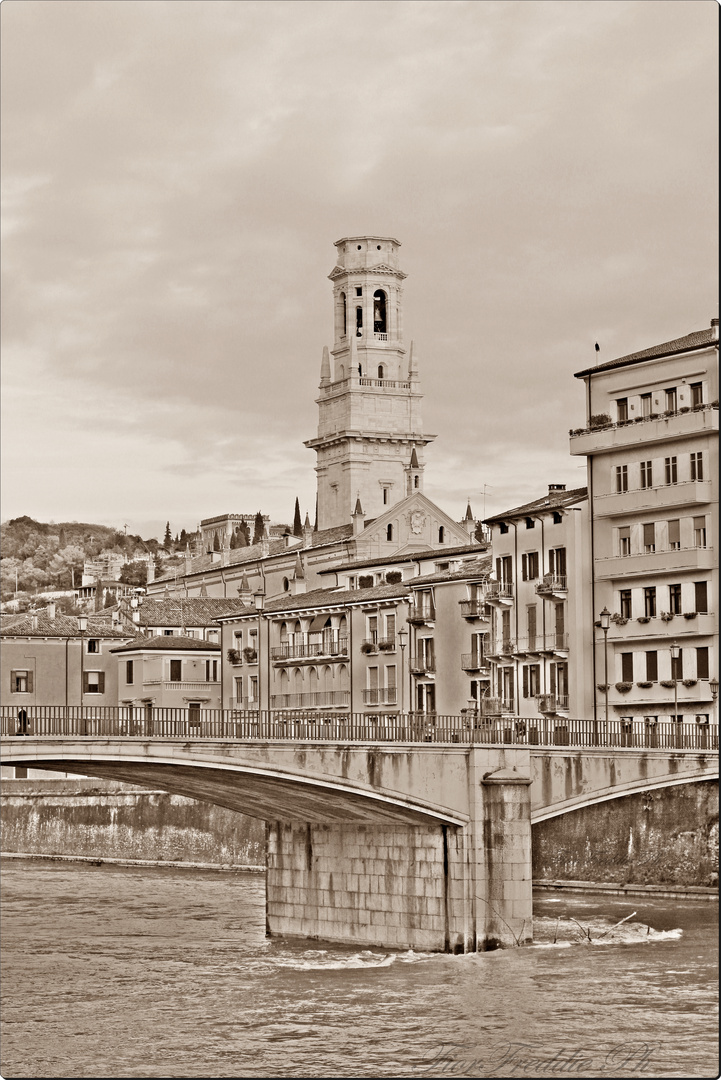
[570, 406, 719, 454]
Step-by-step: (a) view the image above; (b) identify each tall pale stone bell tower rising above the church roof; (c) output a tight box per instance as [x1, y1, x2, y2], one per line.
[305, 235, 435, 529]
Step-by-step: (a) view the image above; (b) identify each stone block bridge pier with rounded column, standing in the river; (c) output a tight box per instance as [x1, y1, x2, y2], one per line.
[266, 748, 532, 953]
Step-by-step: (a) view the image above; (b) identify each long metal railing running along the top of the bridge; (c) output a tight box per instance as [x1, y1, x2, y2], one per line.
[0, 704, 719, 752]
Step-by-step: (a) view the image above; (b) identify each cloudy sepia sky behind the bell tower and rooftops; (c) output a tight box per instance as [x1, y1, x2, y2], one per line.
[0, 0, 719, 535]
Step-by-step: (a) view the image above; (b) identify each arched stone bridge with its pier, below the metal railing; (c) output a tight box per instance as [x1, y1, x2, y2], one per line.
[1, 734, 718, 951]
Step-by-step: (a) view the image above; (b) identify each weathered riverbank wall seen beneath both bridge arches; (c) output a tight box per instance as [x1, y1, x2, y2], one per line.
[0, 777, 719, 889]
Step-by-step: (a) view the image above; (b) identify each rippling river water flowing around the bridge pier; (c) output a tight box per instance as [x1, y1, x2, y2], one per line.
[0, 860, 718, 1078]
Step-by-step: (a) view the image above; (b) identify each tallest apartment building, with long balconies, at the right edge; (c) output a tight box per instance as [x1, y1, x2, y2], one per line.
[571, 319, 719, 726]
